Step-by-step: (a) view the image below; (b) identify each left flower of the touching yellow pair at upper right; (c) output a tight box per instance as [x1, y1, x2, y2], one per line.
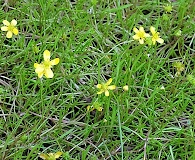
[133, 27, 150, 44]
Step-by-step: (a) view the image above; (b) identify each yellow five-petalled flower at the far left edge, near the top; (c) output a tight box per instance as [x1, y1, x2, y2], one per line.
[1, 19, 18, 38]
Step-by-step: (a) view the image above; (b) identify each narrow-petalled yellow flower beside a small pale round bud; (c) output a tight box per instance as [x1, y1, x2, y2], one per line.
[96, 78, 116, 96]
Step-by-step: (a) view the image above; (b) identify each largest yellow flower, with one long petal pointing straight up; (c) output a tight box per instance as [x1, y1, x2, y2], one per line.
[34, 50, 60, 78]
